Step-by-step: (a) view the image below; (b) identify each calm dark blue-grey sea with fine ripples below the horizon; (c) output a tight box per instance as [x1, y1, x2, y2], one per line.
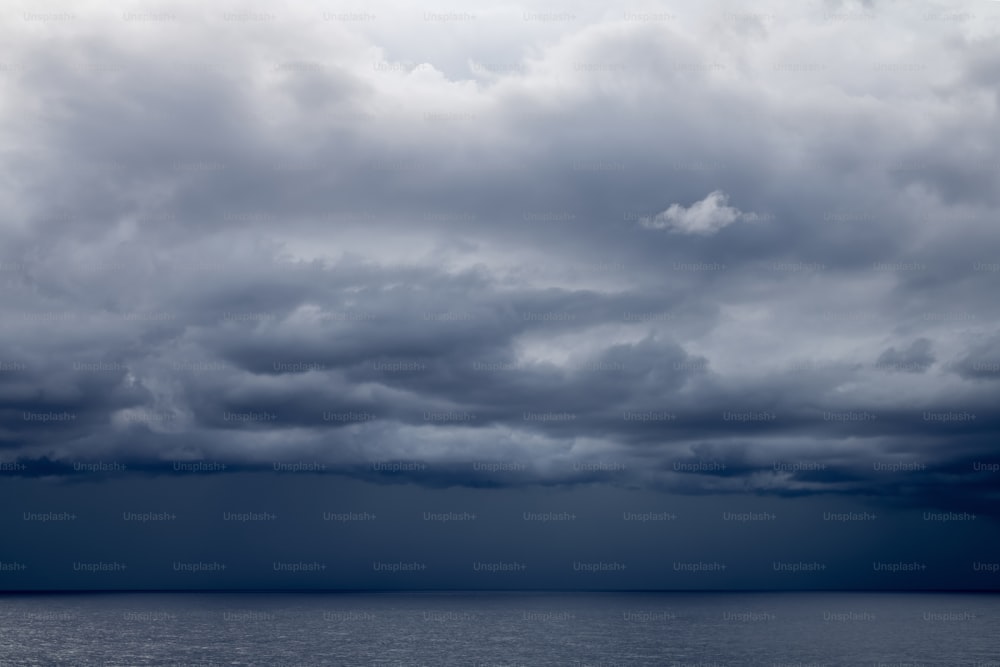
[0, 593, 1000, 667]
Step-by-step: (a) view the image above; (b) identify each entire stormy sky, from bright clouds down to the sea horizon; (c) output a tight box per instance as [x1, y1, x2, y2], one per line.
[0, 0, 1000, 590]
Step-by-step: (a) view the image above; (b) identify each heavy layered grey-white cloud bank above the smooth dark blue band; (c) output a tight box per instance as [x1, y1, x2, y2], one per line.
[0, 2, 1000, 528]
